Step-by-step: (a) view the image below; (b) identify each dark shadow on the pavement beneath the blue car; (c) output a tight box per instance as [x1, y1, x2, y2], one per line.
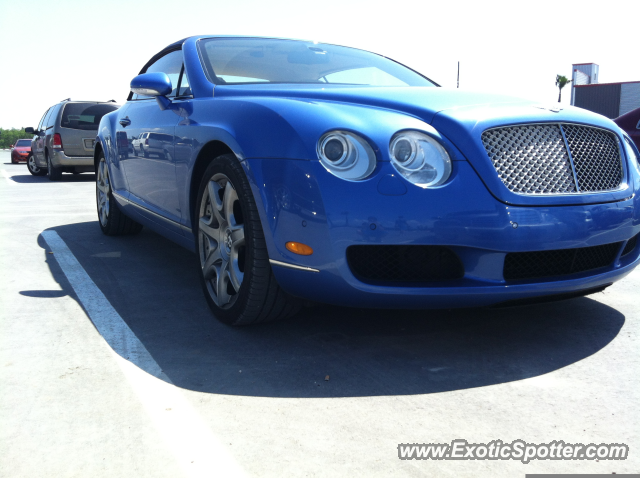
[37, 222, 625, 397]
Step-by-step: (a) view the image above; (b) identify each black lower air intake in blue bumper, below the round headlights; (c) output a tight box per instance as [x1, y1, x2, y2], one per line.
[347, 246, 464, 283]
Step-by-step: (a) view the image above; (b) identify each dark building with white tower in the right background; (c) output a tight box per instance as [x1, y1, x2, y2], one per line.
[571, 63, 640, 118]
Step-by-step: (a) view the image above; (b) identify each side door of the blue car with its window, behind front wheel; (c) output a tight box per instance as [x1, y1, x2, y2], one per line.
[116, 50, 182, 225]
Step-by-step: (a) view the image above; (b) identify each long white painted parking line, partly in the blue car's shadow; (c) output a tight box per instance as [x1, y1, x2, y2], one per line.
[42, 231, 244, 477]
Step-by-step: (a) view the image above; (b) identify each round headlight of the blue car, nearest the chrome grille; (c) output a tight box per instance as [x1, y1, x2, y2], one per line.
[389, 131, 451, 188]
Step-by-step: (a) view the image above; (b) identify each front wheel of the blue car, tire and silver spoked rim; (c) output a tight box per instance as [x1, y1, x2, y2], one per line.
[193, 154, 301, 325]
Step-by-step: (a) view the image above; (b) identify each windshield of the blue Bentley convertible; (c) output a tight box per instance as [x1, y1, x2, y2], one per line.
[198, 38, 436, 86]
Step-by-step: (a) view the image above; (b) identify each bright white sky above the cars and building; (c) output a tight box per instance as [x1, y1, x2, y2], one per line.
[0, 0, 640, 128]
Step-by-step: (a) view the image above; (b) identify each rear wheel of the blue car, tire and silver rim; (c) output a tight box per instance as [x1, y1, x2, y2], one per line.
[96, 153, 142, 236]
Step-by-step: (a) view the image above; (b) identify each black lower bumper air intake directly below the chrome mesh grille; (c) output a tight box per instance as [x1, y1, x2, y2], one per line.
[503, 242, 622, 282]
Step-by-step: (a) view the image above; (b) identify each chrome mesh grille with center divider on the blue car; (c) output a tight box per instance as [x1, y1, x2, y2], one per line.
[482, 123, 623, 194]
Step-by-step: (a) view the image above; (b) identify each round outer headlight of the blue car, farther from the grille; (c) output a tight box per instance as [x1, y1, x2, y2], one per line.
[317, 131, 376, 181]
